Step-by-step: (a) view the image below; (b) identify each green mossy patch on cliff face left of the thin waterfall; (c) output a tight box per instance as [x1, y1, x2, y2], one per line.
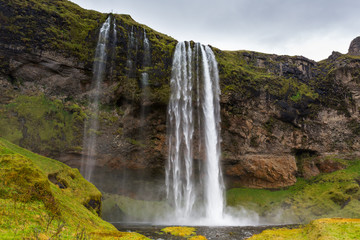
[0, 95, 86, 153]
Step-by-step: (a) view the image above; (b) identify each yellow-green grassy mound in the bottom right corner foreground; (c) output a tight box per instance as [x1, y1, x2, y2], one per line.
[249, 218, 360, 240]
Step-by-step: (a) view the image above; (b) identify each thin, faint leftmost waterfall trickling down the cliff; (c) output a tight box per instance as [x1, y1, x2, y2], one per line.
[80, 16, 115, 181]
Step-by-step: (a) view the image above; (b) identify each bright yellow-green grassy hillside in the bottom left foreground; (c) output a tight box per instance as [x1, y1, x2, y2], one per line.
[0, 138, 147, 239]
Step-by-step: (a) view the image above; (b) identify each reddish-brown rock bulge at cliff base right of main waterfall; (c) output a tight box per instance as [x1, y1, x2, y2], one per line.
[225, 155, 297, 188]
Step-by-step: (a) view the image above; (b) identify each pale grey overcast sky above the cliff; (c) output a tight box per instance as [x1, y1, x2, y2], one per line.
[71, 0, 360, 61]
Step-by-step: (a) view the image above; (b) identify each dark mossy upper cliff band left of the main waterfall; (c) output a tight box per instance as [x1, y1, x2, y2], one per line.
[0, 0, 177, 104]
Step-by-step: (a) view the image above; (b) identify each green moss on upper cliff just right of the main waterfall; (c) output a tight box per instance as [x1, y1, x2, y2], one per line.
[214, 49, 319, 109]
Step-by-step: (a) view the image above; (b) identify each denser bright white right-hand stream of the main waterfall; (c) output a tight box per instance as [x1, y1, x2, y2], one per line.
[200, 46, 224, 219]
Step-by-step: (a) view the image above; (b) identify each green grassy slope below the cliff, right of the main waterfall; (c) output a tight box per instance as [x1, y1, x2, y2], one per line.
[227, 156, 360, 223]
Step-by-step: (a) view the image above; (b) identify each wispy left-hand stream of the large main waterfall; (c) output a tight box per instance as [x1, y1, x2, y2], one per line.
[166, 42, 195, 219]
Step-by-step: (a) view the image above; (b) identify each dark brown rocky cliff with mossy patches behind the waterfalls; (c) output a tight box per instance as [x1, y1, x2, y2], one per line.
[0, 0, 360, 194]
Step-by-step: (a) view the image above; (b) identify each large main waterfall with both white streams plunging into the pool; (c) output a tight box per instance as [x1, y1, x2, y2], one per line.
[166, 42, 224, 223]
